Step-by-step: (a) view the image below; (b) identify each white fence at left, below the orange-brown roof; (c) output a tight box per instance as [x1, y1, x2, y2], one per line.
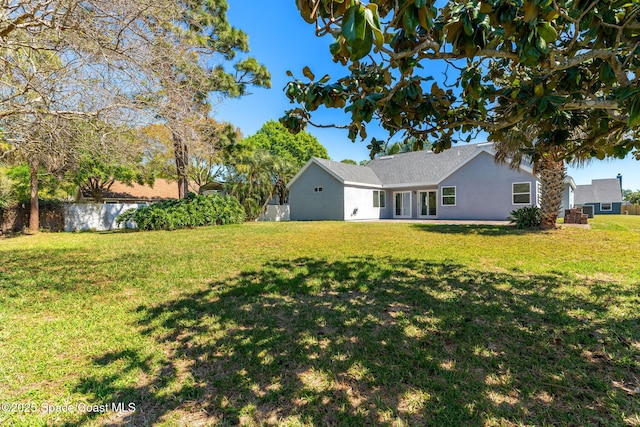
[64, 203, 145, 231]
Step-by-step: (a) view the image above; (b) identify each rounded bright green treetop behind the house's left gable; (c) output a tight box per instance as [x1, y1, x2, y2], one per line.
[246, 120, 329, 168]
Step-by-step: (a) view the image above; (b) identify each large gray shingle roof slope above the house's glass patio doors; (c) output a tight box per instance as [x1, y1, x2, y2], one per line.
[367, 144, 491, 185]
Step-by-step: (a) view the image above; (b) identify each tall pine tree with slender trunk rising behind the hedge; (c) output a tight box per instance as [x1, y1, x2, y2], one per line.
[148, 0, 271, 197]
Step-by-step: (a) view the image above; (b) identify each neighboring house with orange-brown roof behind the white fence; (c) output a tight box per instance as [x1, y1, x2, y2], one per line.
[76, 179, 178, 204]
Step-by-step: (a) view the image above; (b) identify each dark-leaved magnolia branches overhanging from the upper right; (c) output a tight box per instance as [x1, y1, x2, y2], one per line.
[281, 0, 640, 162]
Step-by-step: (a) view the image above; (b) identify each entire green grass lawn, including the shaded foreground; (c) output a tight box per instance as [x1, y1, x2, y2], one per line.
[0, 216, 640, 426]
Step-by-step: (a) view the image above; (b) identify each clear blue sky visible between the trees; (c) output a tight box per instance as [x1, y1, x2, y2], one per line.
[214, 0, 640, 190]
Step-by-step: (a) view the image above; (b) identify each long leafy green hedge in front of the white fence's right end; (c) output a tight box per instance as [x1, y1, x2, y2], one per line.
[116, 194, 246, 230]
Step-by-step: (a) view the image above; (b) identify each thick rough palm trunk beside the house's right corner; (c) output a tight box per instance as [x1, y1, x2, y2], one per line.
[538, 156, 566, 228]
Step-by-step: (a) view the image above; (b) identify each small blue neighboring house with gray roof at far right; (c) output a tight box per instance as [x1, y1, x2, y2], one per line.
[575, 176, 622, 217]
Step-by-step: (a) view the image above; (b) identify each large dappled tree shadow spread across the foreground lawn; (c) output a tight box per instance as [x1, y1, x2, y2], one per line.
[67, 257, 640, 426]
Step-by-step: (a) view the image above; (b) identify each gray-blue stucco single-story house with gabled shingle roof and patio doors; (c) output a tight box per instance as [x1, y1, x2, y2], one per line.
[289, 143, 540, 224]
